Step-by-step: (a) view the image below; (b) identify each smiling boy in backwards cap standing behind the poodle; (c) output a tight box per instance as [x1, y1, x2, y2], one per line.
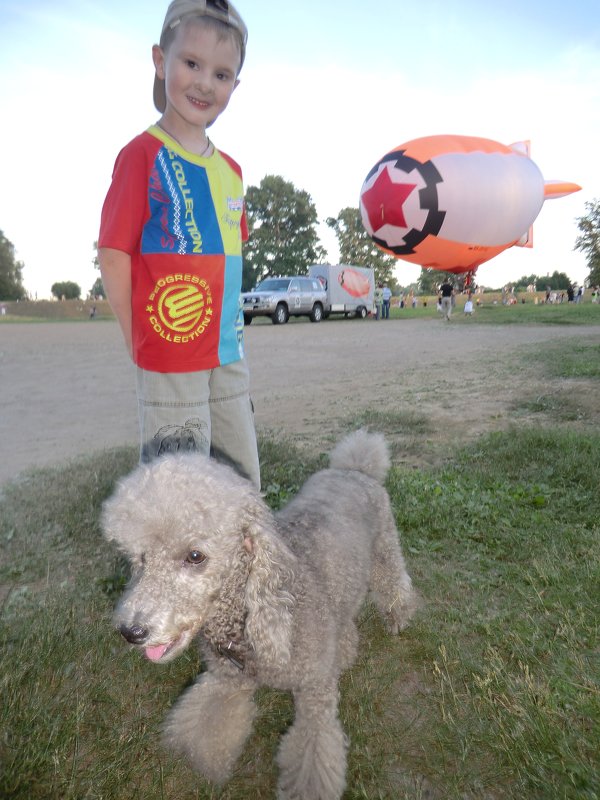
[98, 0, 260, 486]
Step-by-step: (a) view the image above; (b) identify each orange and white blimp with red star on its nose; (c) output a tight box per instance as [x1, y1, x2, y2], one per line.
[360, 136, 581, 273]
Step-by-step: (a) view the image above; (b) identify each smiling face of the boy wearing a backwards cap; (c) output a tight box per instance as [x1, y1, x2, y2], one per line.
[152, 21, 240, 130]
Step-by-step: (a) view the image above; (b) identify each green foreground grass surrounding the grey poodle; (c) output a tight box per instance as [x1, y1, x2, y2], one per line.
[0, 428, 600, 800]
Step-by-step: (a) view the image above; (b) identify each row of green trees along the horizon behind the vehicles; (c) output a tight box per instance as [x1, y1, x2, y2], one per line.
[0, 183, 600, 300]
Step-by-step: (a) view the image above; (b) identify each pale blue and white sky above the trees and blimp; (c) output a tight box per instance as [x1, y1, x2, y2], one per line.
[0, 0, 600, 299]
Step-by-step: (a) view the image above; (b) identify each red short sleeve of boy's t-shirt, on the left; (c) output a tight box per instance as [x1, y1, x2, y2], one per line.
[98, 137, 149, 255]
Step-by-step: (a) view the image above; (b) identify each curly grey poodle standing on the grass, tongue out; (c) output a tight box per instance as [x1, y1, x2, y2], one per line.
[103, 431, 415, 800]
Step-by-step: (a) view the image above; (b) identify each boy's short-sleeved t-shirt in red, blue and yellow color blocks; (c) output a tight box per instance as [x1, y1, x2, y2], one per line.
[98, 126, 248, 372]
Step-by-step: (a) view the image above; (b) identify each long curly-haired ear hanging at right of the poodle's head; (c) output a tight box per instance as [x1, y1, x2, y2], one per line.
[244, 502, 296, 667]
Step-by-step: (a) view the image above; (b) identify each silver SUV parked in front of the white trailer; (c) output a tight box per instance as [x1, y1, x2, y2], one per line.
[242, 275, 327, 325]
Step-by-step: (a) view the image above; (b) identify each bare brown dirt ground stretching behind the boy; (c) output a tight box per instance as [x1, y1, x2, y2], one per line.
[0, 319, 600, 483]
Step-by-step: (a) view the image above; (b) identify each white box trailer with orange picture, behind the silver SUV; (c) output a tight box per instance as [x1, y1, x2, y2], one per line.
[308, 264, 375, 319]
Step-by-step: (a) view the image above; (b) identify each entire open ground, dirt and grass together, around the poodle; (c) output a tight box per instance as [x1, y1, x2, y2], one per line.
[0, 314, 600, 800]
